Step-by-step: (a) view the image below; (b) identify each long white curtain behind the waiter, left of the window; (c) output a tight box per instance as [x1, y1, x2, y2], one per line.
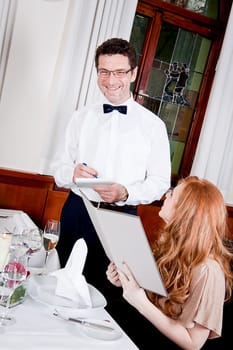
[40, 0, 137, 174]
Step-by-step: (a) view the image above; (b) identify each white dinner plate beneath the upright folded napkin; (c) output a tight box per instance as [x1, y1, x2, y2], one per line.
[27, 275, 107, 309]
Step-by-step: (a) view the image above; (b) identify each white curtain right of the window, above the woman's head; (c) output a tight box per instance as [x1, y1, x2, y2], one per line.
[191, 3, 233, 205]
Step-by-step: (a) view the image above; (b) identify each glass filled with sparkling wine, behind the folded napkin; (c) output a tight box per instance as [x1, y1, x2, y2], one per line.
[42, 219, 60, 268]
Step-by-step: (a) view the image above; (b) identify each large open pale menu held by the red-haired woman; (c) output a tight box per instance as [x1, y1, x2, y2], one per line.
[80, 191, 167, 296]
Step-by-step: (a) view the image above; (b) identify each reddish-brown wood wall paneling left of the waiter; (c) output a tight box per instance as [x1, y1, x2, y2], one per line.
[0, 168, 68, 227]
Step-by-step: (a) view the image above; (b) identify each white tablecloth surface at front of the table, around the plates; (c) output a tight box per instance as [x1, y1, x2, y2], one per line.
[0, 296, 138, 350]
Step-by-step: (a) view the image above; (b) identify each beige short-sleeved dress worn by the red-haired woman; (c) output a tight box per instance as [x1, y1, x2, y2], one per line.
[179, 259, 225, 338]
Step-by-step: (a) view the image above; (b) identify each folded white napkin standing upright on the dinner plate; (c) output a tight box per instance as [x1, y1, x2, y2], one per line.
[50, 238, 92, 307]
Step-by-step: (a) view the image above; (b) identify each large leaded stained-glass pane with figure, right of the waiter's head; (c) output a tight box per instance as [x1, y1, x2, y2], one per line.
[131, 19, 211, 174]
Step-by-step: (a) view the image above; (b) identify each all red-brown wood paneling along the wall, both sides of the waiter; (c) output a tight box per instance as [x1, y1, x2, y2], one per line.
[0, 168, 233, 243]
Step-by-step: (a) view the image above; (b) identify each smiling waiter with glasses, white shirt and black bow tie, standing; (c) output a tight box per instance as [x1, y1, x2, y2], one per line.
[54, 38, 171, 296]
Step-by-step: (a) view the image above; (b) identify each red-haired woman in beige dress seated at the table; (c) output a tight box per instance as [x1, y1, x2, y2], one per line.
[107, 176, 233, 349]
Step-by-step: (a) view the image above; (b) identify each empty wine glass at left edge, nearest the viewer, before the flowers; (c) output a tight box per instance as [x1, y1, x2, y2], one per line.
[0, 256, 27, 327]
